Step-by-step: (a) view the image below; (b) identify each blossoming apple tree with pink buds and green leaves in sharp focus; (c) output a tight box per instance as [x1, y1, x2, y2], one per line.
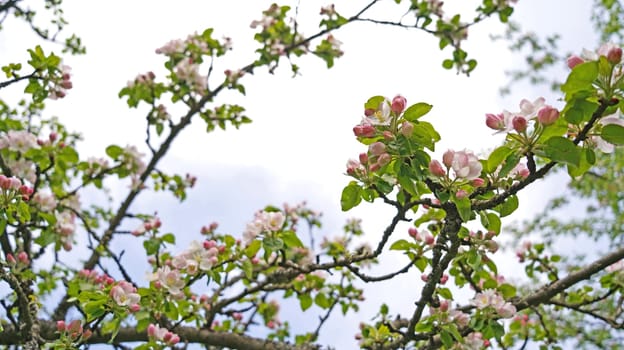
[0, 0, 624, 349]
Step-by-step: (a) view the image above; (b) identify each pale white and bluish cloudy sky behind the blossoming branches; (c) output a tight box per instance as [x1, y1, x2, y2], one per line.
[0, 0, 597, 349]
